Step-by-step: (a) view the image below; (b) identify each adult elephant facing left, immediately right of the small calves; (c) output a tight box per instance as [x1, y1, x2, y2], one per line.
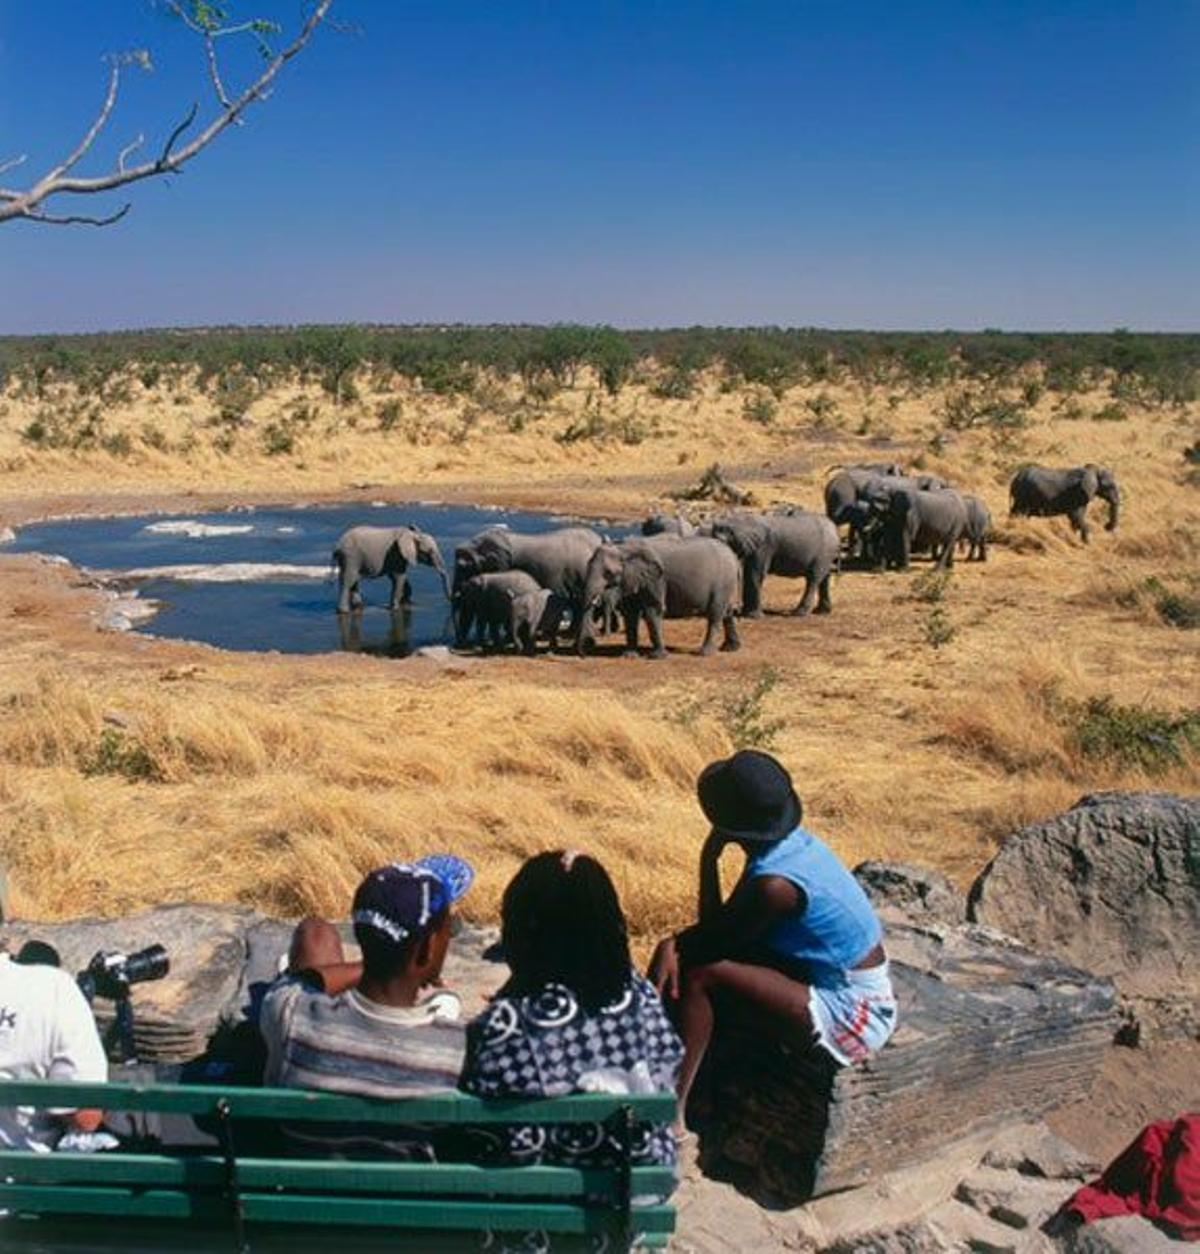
[576, 535, 741, 657]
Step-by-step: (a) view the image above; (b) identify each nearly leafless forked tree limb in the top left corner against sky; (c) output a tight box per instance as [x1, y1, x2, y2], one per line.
[0, 0, 334, 227]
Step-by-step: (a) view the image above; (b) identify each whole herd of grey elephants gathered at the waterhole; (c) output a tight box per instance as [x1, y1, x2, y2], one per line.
[332, 463, 1120, 657]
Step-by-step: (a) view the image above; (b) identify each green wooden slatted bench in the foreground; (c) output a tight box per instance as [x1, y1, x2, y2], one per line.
[0, 1081, 675, 1251]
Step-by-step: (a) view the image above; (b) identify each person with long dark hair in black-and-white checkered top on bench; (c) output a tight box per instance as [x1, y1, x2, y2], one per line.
[460, 850, 683, 1166]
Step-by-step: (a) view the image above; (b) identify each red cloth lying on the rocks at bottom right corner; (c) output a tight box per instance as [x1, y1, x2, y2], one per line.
[1063, 1114, 1200, 1241]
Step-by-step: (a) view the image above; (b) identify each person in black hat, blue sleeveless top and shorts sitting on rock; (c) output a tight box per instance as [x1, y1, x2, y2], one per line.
[650, 749, 897, 1134]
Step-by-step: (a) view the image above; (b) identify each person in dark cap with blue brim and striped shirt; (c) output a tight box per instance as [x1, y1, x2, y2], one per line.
[260, 854, 474, 1161]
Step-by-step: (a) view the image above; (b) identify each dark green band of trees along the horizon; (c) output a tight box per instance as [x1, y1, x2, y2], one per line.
[0, 324, 1200, 405]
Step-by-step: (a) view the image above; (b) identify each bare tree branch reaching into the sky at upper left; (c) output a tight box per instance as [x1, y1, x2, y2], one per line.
[0, 0, 334, 226]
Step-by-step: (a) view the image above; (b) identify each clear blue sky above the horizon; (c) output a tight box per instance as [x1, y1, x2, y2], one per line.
[0, 0, 1200, 332]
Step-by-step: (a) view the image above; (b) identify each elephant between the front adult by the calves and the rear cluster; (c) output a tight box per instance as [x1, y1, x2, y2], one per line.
[712, 514, 841, 618]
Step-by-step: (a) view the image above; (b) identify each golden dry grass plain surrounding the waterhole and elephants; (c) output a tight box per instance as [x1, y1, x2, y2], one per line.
[0, 366, 1200, 941]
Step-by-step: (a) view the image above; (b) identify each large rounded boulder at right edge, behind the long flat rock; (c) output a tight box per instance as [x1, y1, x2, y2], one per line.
[968, 793, 1200, 1035]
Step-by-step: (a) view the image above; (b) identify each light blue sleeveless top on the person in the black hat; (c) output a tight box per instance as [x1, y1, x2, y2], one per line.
[745, 828, 883, 987]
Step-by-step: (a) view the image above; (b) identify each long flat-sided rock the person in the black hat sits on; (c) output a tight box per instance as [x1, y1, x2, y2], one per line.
[702, 924, 1116, 1205]
